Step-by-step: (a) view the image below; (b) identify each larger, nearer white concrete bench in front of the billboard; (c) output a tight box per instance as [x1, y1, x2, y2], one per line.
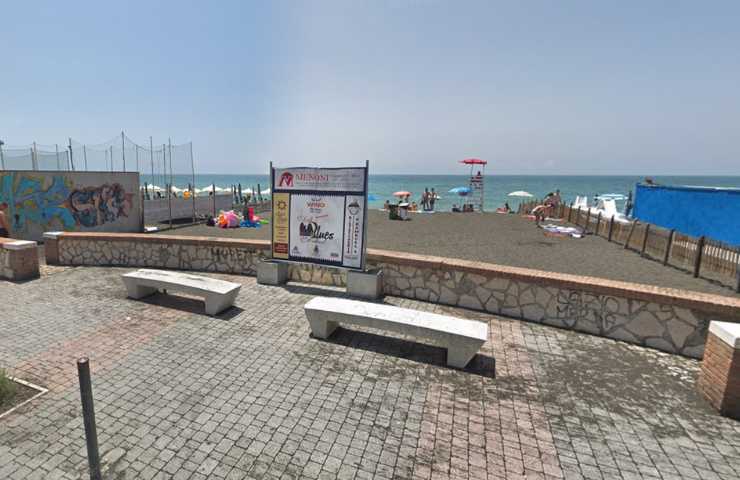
[304, 297, 488, 368]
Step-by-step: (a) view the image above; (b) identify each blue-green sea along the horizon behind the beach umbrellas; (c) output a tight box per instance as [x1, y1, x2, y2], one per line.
[141, 174, 740, 211]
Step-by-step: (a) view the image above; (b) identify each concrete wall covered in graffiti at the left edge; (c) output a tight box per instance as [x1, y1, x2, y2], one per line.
[0, 171, 142, 241]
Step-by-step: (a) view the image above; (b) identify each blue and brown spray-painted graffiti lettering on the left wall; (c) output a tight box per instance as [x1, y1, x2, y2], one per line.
[0, 173, 133, 236]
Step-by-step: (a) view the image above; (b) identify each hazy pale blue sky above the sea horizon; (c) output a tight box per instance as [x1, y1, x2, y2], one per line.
[0, 0, 740, 175]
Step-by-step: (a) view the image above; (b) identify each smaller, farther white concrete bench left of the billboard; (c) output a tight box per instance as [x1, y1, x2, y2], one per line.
[121, 269, 241, 315]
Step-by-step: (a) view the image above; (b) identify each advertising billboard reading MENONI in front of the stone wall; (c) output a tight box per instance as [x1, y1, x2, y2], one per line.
[270, 162, 369, 270]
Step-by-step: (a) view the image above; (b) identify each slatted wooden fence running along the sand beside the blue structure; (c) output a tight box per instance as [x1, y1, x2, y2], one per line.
[518, 201, 740, 293]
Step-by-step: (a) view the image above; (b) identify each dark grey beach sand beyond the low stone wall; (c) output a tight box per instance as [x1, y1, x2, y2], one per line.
[162, 210, 736, 295]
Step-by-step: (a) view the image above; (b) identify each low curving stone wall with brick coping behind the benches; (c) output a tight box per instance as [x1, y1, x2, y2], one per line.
[47, 233, 740, 358]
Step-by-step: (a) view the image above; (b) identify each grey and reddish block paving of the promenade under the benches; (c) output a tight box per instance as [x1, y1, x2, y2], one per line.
[0, 266, 740, 479]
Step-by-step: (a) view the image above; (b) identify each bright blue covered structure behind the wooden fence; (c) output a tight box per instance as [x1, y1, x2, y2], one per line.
[633, 184, 740, 245]
